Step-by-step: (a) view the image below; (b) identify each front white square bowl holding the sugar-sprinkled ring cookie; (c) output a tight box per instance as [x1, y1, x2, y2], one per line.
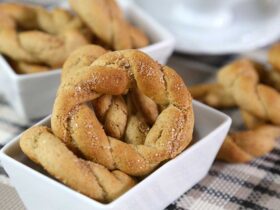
[0, 101, 231, 210]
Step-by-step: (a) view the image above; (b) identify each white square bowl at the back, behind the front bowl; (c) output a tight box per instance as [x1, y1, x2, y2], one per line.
[0, 2, 175, 121]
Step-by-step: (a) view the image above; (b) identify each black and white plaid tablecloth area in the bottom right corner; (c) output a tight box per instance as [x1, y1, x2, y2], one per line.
[167, 144, 280, 210]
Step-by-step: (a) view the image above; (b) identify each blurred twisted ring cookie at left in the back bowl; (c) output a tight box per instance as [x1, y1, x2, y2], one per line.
[0, 3, 88, 69]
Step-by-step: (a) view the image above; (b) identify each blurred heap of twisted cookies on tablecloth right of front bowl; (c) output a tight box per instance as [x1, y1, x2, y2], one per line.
[190, 56, 280, 162]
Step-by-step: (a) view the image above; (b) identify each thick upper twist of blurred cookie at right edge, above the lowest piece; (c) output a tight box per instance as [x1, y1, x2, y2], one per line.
[218, 59, 280, 125]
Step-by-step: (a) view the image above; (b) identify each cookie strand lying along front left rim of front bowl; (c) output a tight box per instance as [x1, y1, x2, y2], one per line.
[20, 126, 135, 202]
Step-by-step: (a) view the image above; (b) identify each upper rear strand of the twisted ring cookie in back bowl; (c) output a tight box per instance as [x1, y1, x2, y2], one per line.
[0, 3, 84, 34]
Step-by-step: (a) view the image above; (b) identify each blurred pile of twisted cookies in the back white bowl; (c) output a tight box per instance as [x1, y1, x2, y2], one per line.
[0, 0, 148, 74]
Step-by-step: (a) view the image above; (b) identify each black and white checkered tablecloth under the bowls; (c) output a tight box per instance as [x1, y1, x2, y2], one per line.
[0, 56, 280, 210]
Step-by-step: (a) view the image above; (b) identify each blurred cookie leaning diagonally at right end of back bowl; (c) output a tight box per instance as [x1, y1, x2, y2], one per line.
[69, 0, 148, 50]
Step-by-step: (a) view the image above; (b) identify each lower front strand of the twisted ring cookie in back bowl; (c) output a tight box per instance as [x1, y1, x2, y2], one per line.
[0, 30, 88, 68]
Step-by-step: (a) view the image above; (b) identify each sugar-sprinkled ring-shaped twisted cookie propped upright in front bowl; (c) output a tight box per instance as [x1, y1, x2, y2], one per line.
[51, 45, 194, 176]
